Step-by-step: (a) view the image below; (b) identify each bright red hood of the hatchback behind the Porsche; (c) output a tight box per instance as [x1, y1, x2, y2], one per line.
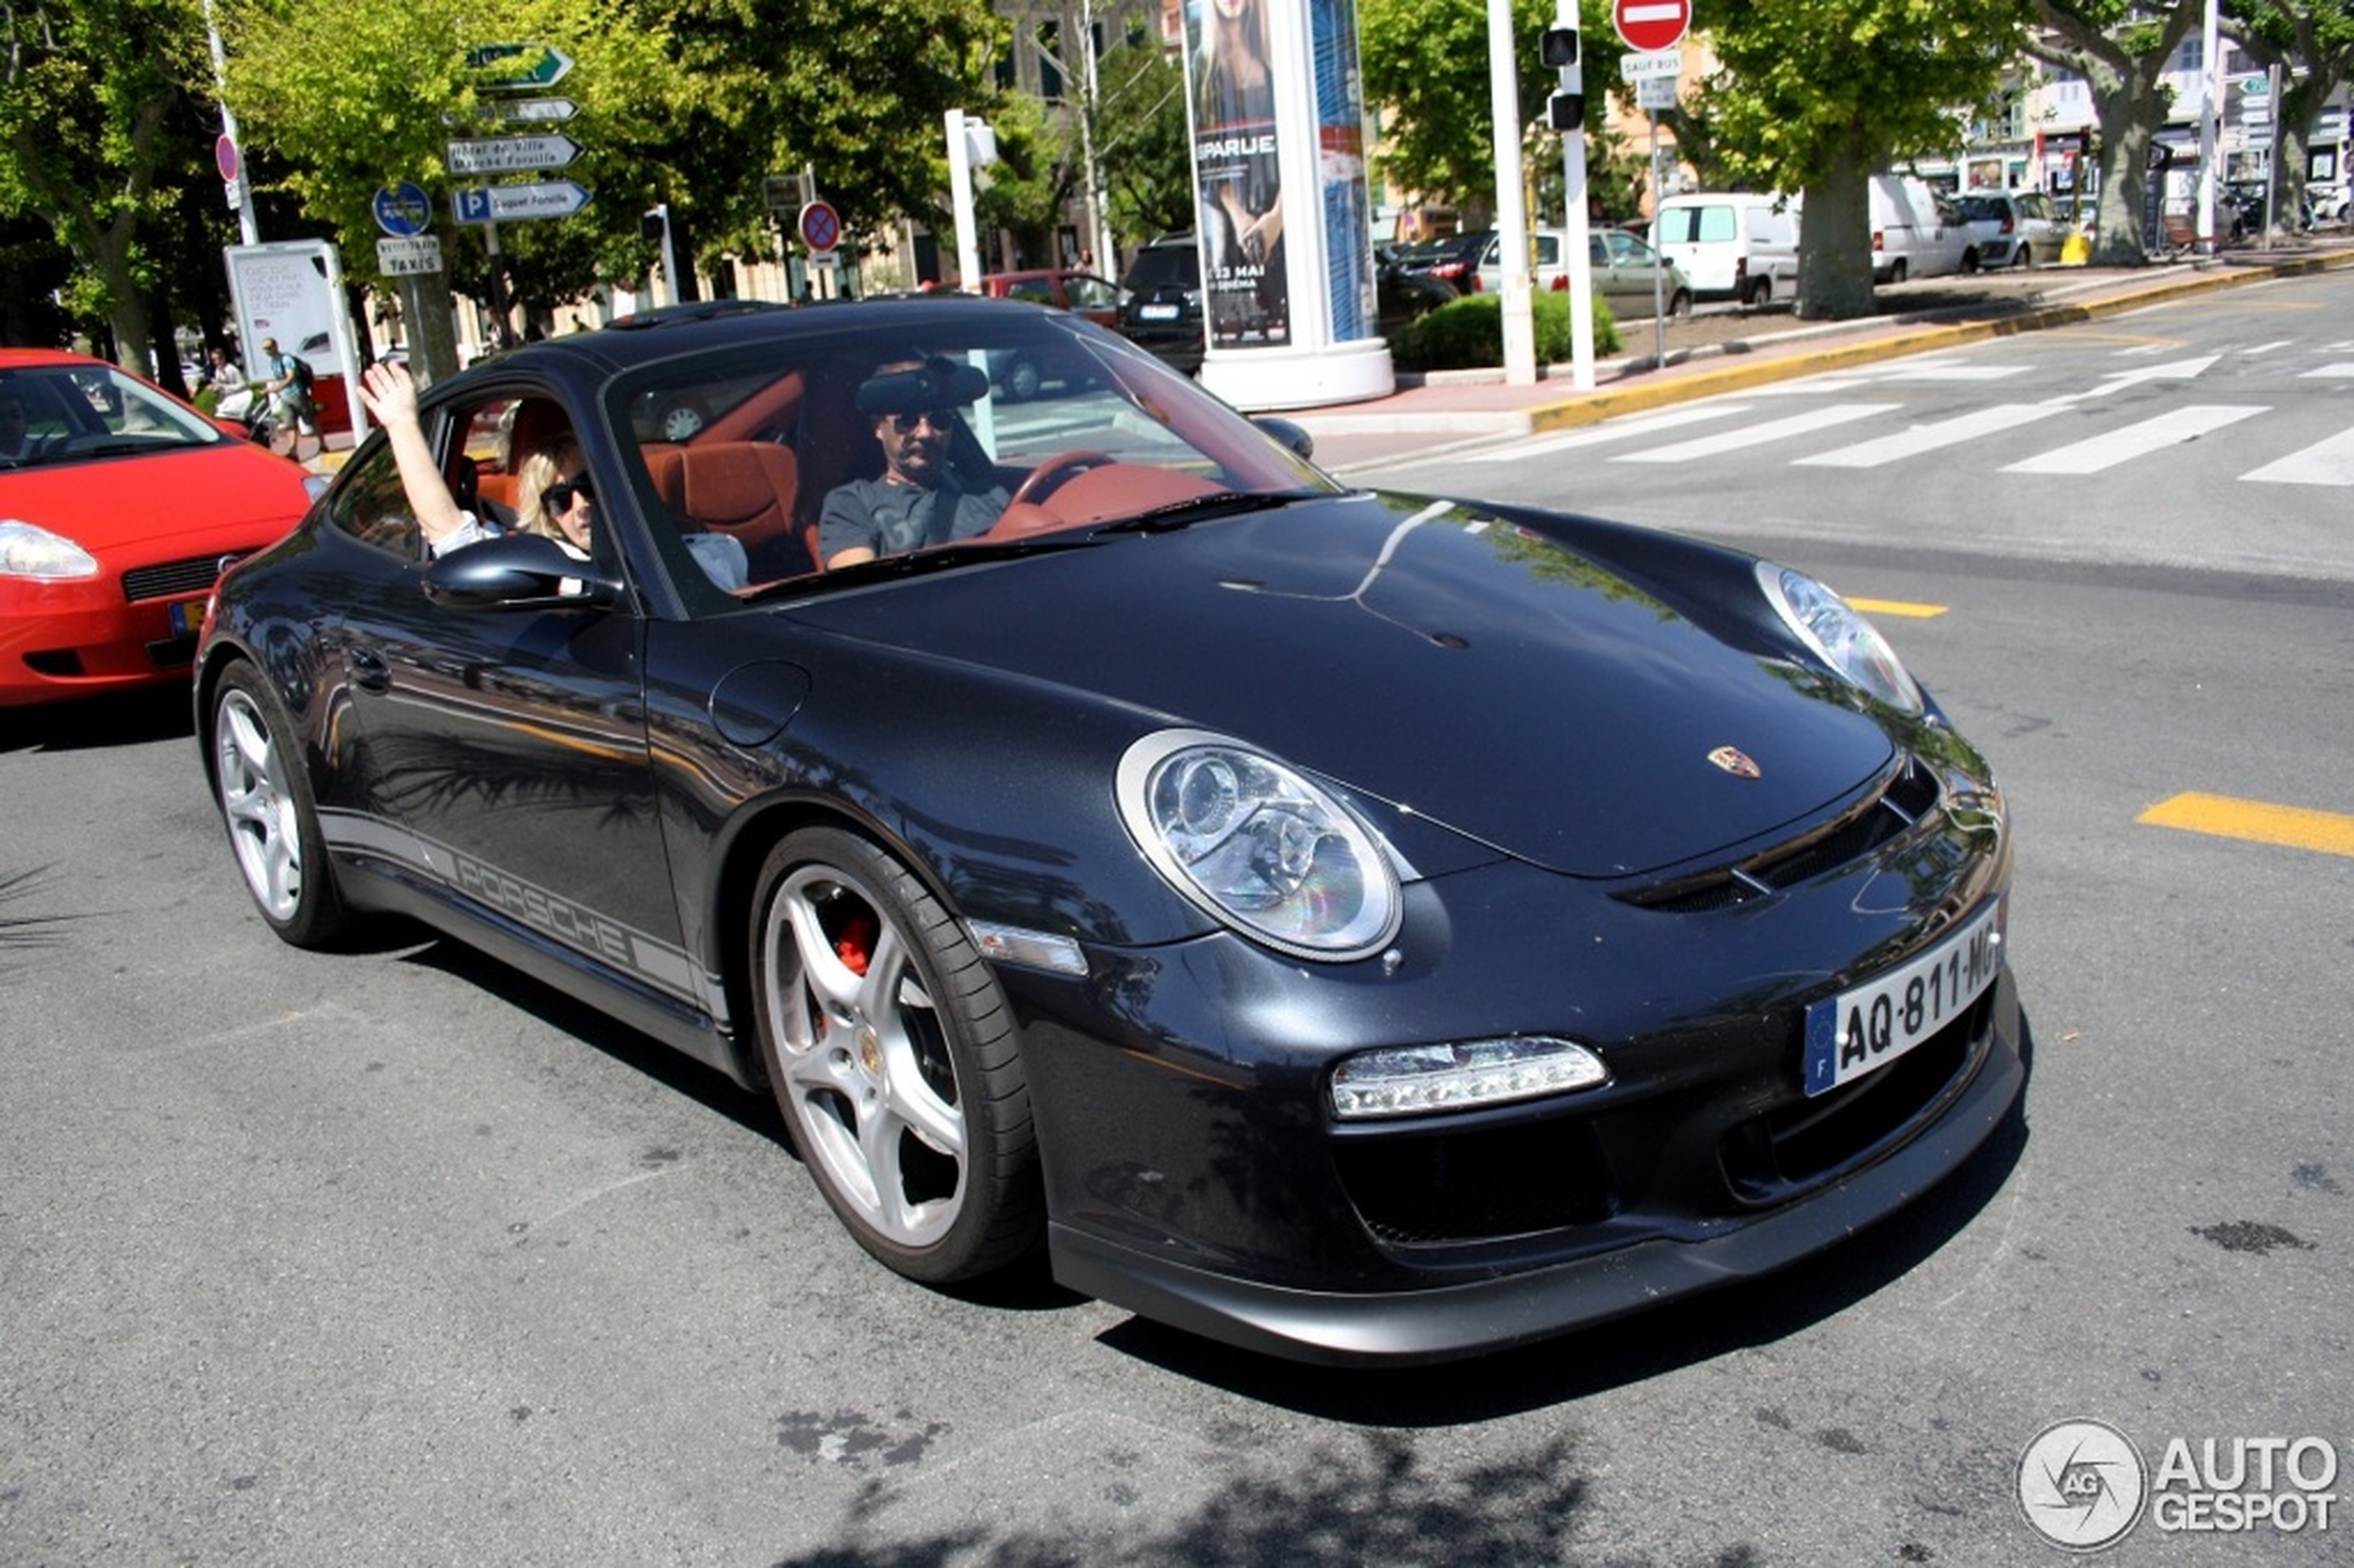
[0, 440, 310, 546]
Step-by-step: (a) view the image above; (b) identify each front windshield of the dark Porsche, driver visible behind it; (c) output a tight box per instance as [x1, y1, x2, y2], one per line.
[605, 309, 1337, 614]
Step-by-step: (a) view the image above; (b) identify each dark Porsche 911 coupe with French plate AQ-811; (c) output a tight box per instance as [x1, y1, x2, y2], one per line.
[196, 297, 2024, 1360]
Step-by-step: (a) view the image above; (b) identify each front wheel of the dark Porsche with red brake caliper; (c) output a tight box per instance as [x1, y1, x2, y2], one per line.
[751, 827, 1045, 1285]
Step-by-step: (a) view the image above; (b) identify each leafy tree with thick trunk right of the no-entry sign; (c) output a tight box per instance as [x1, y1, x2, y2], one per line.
[1707, 0, 2027, 318]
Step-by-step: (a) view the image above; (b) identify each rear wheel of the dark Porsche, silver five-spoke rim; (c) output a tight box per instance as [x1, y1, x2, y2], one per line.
[208, 662, 350, 946]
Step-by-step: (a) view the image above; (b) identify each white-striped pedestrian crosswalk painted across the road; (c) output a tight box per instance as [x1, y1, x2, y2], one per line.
[1440, 339, 2354, 487]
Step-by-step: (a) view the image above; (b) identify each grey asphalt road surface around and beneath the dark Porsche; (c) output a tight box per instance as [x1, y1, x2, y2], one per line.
[0, 284, 2354, 1568]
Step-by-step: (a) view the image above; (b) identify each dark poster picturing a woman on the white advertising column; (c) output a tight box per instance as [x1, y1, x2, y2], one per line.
[1186, 0, 1292, 348]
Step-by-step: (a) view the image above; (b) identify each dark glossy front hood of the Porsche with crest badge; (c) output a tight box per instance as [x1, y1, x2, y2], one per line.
[791, 497, 1892, 876]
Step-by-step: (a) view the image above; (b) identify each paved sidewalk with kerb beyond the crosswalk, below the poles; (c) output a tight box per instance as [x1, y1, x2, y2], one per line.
[1285, 231, 2354, 471]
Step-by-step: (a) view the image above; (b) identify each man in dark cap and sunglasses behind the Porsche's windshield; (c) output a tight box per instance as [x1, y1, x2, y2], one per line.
[816, 356, 1010, 570]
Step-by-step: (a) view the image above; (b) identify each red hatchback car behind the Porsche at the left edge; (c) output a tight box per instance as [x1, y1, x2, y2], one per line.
[0, 348, 323, 709]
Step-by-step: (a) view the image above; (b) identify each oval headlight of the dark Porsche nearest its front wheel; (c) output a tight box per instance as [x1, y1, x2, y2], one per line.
[1116, 730, 1400, 961]
